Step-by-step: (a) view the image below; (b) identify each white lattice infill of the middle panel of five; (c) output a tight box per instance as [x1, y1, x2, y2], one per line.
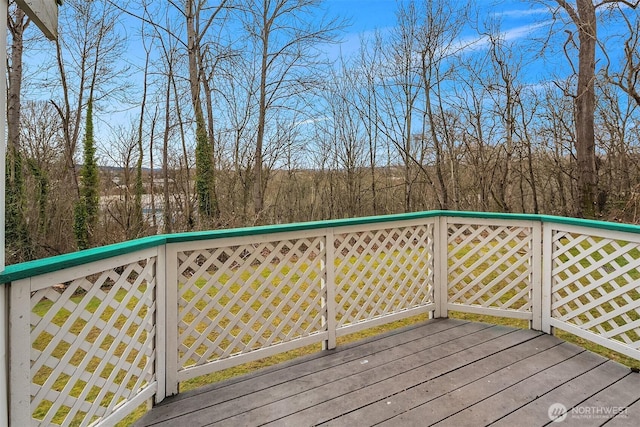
[334, 224, 433, 328]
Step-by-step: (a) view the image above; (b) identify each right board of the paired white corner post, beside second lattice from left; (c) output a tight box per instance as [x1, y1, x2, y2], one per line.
[164, 244, 181, 396]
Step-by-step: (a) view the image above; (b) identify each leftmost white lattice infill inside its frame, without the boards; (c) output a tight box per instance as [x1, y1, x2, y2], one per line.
[31, 258, 156, 425]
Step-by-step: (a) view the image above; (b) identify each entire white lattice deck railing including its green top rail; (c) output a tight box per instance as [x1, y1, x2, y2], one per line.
[0, 212, 640, 426]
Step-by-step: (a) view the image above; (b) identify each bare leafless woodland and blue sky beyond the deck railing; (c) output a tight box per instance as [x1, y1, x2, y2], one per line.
[6, 0, 640, 263]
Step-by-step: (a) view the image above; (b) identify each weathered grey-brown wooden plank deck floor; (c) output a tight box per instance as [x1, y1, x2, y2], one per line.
[136, 319, 640, 427]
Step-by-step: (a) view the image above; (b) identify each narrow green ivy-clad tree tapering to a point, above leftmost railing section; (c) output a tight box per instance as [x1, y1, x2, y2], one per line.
[73, 99, 100, 249]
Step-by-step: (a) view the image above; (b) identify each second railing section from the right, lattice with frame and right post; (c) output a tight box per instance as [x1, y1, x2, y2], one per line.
[443, 218, 542, 329]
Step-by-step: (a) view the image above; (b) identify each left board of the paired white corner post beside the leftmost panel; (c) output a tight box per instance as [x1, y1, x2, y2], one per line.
[154, 245, 167, 404]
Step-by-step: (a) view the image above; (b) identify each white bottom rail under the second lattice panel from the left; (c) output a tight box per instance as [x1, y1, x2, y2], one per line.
[177, 332, 329, 382]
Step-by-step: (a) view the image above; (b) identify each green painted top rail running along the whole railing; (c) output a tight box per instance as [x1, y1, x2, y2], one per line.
[0, 211, 640, 284]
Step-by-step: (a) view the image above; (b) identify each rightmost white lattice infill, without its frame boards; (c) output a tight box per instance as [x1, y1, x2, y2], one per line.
[551, 231, 640, 349]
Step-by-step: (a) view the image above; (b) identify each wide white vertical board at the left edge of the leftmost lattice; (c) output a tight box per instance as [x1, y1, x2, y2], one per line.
[9, 279, 31, 426]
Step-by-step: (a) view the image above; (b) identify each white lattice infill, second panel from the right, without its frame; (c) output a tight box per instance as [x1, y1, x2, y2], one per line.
[447, 223, 533, 312]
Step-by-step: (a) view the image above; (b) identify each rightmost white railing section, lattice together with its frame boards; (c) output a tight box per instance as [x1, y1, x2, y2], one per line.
[542, 224, 640, 359]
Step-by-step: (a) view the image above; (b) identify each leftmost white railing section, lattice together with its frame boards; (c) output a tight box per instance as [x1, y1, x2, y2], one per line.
[9, 249, 158, 426]
